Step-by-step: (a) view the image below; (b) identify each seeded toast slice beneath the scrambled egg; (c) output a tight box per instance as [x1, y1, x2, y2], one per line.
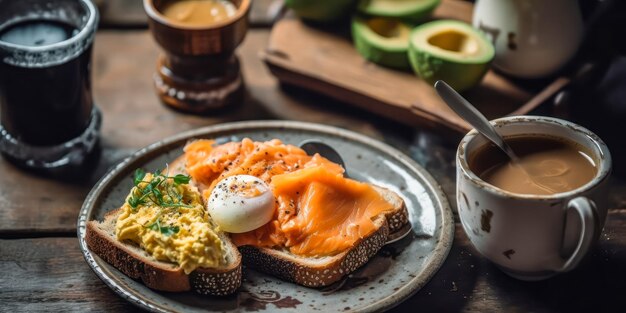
[85, 162, 242, 296]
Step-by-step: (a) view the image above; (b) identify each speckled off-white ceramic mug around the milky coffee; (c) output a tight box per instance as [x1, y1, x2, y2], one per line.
[456, 116, 611, 280]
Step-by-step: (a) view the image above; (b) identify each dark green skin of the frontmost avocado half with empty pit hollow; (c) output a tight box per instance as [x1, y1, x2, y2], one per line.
[409, 44, 489, 92]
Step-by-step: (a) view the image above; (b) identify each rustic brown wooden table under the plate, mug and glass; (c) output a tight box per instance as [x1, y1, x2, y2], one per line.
[0, 1, 626, 312]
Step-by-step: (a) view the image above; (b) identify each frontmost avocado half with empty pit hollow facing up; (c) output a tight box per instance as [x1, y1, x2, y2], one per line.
[409, 20, 494, 91]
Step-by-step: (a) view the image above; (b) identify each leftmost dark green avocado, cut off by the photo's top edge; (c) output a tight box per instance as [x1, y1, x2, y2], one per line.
[285, 0, 355, 23]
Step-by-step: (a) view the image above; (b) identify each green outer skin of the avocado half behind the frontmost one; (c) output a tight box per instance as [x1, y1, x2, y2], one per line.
[352, 18, 411, 69]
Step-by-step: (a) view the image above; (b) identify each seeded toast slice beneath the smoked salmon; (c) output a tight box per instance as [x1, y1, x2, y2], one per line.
[234, 186, 408, 287]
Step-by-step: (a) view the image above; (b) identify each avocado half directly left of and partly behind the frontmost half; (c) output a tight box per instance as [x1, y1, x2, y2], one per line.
[352, 17, 411, 69]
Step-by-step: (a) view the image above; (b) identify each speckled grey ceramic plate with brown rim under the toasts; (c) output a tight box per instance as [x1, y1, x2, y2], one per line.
[78, 121, 454, 312]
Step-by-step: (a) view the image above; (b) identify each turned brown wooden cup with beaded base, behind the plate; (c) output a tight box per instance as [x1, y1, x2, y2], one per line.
[143, 0, 251, 114]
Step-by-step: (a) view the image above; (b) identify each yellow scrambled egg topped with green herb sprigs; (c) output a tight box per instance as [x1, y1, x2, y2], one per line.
[115, 173, 227, 274]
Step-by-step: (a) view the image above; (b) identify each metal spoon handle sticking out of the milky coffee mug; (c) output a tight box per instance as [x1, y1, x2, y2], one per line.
[435, 80, 520, 164]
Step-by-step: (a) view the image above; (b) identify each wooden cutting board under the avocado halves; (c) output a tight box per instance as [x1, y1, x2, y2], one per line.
[261, 0, 562, 132]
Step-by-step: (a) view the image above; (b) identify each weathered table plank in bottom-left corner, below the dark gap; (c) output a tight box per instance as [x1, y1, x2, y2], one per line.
[0, 238, 136, 312]
